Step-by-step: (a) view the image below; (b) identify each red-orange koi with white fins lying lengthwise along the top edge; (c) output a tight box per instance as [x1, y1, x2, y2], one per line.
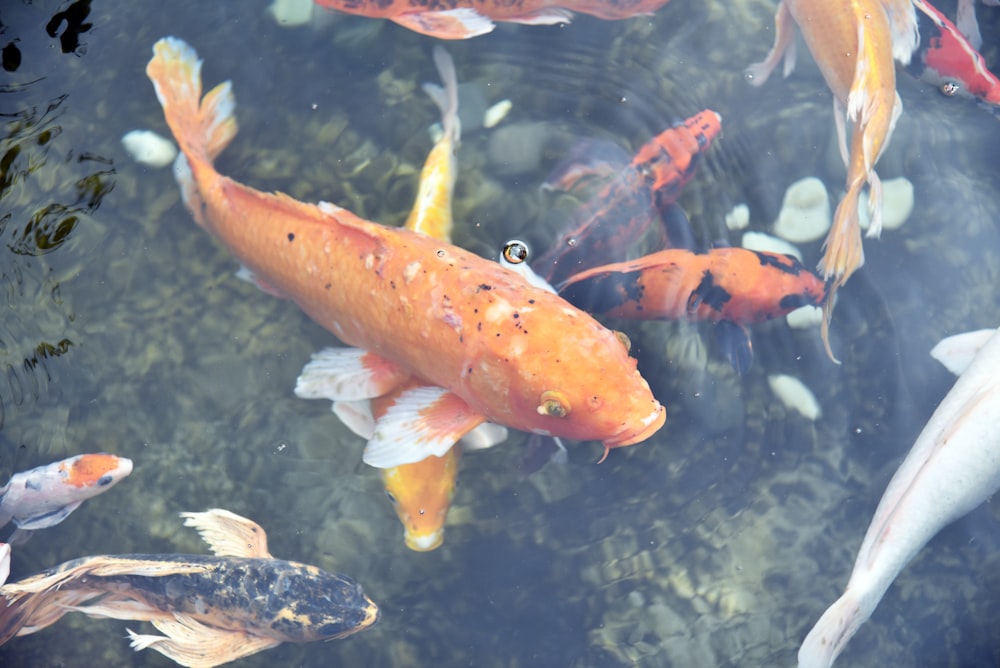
[316, 0, 669, 39]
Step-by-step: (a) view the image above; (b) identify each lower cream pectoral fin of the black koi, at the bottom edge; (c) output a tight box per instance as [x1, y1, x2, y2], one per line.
[127, 614, 281, 668]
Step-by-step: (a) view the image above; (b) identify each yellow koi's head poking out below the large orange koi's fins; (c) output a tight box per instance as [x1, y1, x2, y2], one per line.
[382, 445, 461, 552]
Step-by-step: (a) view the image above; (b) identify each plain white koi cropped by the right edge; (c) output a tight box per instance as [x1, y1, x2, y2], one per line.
[799, 332, 1000, 668]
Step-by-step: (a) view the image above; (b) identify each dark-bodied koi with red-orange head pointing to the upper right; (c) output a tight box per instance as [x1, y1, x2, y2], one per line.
[532, 109, 722, 284]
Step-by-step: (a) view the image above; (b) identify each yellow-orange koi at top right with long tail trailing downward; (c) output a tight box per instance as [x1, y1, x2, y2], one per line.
[746, 0, 919, 361]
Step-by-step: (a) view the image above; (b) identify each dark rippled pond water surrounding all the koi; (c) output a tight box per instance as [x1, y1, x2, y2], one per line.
[0, 0, 1000, 666]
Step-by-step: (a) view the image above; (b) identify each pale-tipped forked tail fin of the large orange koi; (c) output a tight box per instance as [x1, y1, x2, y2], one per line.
[146, 37, 237, 165]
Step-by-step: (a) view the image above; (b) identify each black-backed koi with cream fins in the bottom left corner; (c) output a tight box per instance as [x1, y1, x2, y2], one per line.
[0, 508, 379, 668]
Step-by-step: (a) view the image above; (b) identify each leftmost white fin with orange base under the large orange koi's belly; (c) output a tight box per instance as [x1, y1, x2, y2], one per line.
[295, 348, 410, 401]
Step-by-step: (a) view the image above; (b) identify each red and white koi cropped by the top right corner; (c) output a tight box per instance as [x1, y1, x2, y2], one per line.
[913, 0, 1000, 105]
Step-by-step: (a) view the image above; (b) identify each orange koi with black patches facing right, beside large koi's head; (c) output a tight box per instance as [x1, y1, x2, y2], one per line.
[559, 248, 826, 374]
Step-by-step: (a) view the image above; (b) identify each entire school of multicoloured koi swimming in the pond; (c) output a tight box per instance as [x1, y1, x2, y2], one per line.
[7, 0, 1000, 668]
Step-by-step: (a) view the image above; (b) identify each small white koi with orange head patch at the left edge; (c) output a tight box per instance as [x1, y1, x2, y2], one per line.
[0, 453, 132, 545]
